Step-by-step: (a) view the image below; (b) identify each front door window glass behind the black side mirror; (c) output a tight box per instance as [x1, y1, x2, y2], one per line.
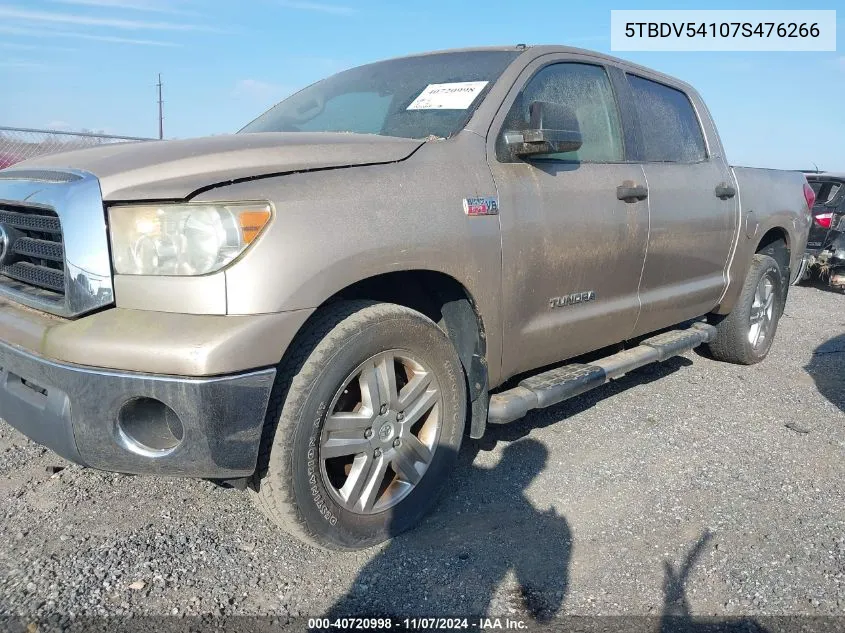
[502, 62, 623, 163]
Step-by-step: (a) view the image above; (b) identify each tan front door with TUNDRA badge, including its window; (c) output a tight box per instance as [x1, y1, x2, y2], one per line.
[488, 55, 648, 375]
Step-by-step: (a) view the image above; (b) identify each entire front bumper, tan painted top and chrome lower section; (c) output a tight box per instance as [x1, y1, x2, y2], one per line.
[0, 299, 312, 479]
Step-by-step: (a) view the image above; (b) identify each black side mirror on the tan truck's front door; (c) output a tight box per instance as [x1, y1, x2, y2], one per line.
[504, 101, 584, 156]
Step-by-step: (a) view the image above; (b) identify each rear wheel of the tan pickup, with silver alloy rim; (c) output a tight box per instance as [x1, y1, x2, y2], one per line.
[708, 253, 786, 365]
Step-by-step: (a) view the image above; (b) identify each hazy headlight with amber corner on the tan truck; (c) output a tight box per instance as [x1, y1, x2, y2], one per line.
[109, 202, 272, 275]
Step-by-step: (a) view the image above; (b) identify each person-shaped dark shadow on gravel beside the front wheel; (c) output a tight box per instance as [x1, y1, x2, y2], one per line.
[326, 439, 572, 622]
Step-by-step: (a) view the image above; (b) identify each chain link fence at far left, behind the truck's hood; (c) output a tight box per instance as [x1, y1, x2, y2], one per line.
[0, 127, 155, 169]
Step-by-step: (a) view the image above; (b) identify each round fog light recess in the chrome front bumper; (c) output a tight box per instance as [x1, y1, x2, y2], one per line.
[117, 398, 185, 457]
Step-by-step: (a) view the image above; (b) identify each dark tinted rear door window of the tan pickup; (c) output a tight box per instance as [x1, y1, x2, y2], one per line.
[628, 75, 707, 163]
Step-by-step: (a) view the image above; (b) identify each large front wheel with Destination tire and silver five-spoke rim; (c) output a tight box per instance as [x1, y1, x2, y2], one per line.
[255, 301, 467, 550]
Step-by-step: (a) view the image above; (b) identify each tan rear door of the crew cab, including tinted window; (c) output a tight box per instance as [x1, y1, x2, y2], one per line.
[626, 72, 738, 336]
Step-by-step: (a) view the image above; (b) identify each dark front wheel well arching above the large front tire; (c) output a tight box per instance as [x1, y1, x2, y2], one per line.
[326, 270, 488, 437]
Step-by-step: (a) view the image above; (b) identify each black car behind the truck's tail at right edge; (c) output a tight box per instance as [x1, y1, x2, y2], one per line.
[798, 172, 845, 290]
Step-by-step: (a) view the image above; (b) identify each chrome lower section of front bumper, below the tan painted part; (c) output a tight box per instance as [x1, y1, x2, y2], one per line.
[0, 343, 276, 479]
